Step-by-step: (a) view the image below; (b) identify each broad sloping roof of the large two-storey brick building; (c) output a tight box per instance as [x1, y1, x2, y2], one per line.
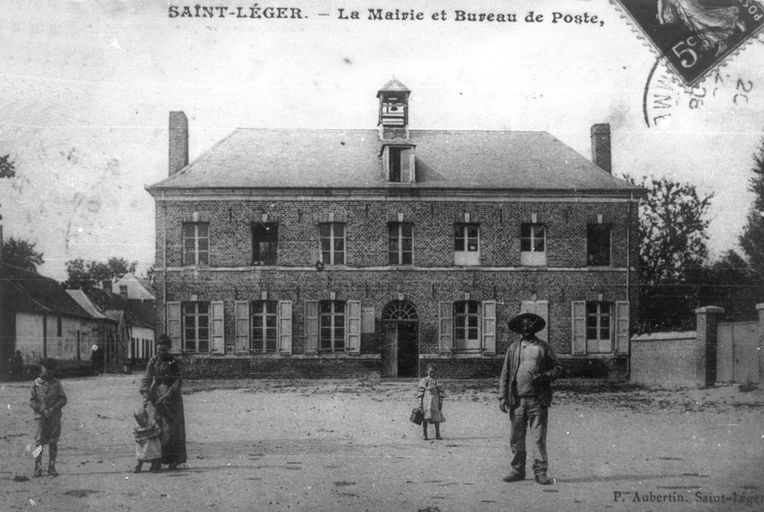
[147, 128, 641, 195]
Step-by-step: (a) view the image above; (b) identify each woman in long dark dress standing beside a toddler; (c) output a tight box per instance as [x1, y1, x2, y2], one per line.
[141, 334, 186, 469]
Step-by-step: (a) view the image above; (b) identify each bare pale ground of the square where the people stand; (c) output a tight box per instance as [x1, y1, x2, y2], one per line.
[0, 376, 764, 512]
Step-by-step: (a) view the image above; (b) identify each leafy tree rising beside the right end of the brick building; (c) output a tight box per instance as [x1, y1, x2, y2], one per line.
[626, 176, 713, 330]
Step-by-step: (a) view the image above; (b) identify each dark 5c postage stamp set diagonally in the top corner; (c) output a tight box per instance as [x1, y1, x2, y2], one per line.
[616, 0, 764, 85]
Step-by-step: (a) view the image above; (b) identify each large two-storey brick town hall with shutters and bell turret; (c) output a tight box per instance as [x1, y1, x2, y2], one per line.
[147, 80, 644, 377]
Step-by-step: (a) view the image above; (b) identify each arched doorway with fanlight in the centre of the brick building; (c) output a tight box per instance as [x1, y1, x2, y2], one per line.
[382, 300, 419, 377]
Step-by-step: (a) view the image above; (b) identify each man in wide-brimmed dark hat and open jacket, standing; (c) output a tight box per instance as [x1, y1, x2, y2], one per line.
[499, 313, 562, 485]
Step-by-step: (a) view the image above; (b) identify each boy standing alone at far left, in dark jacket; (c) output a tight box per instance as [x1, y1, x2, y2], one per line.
[29, 359, 66, 476]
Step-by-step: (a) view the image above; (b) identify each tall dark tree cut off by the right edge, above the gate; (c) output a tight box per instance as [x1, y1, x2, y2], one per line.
[739, 140, 764, 282]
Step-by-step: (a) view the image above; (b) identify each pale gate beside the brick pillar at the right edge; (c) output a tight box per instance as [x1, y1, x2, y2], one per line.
[716, 322, 761, 384]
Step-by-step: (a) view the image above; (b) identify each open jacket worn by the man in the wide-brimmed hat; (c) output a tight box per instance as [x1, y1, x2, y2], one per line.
[499, 336, 562, 407]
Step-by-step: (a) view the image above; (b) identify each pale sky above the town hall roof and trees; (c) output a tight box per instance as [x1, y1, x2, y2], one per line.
[0, 0, 764, 280]
